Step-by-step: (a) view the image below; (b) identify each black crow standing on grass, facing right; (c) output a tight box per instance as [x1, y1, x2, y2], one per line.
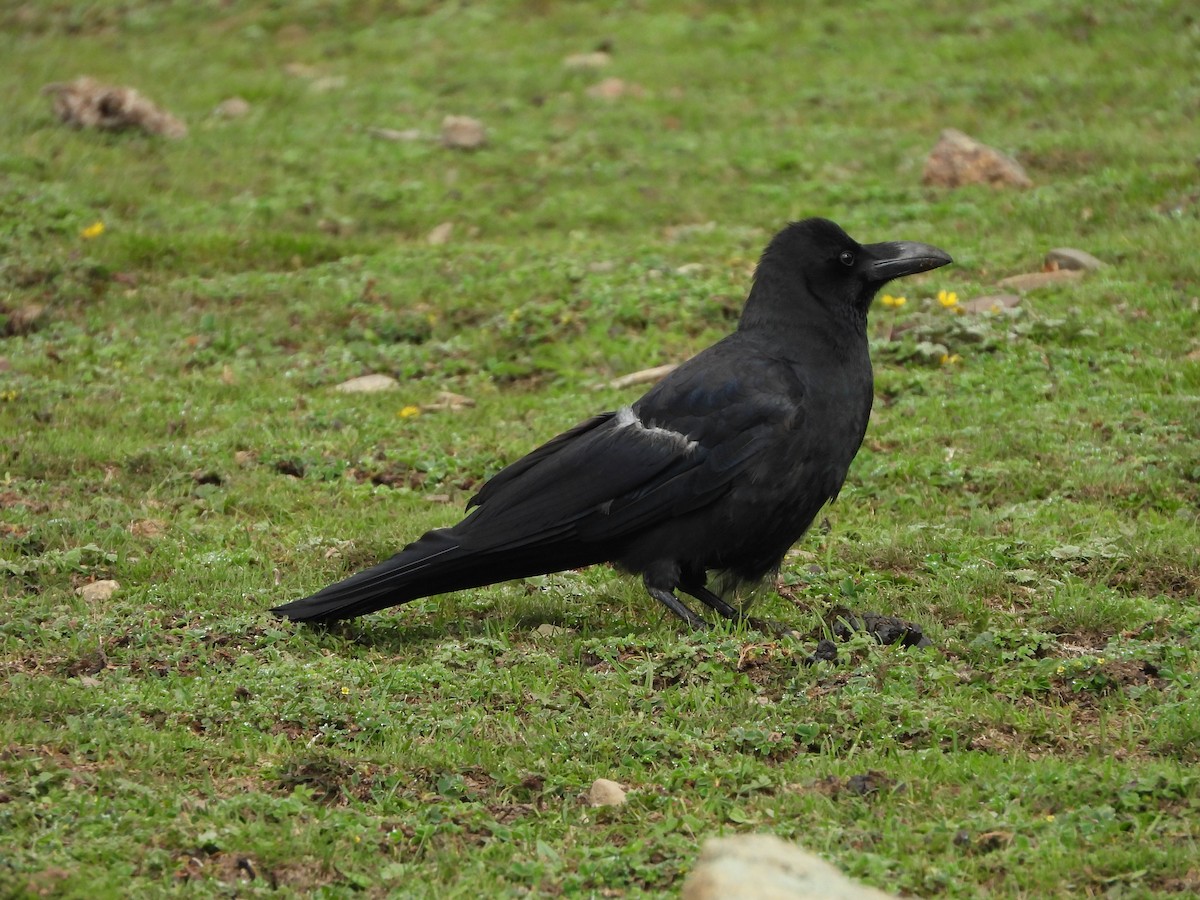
[272, 218, 952, 629]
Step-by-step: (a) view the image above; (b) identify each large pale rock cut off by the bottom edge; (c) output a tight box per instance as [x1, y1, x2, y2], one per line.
[680, 834, 894, 900]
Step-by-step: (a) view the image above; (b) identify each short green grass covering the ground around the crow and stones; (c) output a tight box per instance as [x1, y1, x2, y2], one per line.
[0, 0, 1200, 898]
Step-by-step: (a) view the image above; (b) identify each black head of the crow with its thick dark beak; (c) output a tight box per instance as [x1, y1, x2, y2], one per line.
[743, 218, 952, 325]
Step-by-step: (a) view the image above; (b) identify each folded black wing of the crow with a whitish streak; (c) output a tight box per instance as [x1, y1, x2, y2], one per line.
[452, 344, 799, 552]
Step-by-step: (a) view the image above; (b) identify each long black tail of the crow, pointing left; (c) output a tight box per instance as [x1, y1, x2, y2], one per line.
[271, 529, 600, 622]
